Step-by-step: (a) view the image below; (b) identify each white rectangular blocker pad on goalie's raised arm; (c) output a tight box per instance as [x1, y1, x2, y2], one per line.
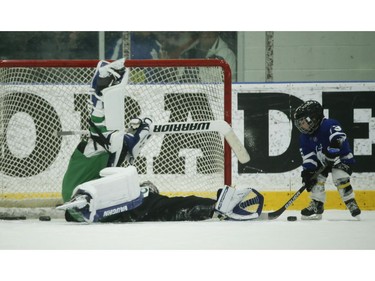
[102, 68, 129, 131]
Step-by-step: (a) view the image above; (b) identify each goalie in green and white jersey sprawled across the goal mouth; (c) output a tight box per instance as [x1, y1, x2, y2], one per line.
[58, 59, 263, 222]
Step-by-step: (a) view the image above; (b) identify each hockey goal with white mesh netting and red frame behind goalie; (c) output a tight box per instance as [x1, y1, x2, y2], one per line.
[0, 60, 231, 212]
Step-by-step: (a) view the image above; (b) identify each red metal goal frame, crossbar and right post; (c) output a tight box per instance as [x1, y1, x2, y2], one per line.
[0, 59, 232, 208]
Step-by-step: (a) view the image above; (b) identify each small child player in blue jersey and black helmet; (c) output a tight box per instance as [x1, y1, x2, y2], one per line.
[294, 100, 361, 220]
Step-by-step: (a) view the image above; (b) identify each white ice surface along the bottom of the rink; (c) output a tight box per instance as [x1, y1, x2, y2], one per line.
[0, 210, 375, 250]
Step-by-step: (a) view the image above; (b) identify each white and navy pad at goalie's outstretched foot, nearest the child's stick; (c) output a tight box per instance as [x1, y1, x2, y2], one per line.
[215, 186, 264, 221]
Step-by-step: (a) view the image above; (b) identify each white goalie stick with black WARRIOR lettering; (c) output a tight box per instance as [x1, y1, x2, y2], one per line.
[56, 120, 250, 164]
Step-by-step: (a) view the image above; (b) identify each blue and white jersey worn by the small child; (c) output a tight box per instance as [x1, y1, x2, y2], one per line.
[299, 118, 354, 170]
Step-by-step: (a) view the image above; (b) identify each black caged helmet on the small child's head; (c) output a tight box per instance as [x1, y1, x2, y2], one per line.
[294, 100, 324, 134]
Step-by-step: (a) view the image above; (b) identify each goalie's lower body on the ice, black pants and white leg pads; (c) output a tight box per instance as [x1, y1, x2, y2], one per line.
[57, 166, 263, 223]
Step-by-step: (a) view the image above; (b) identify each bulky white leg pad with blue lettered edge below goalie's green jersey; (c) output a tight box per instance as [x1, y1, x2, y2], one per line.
[57, 166, 148, 223]
